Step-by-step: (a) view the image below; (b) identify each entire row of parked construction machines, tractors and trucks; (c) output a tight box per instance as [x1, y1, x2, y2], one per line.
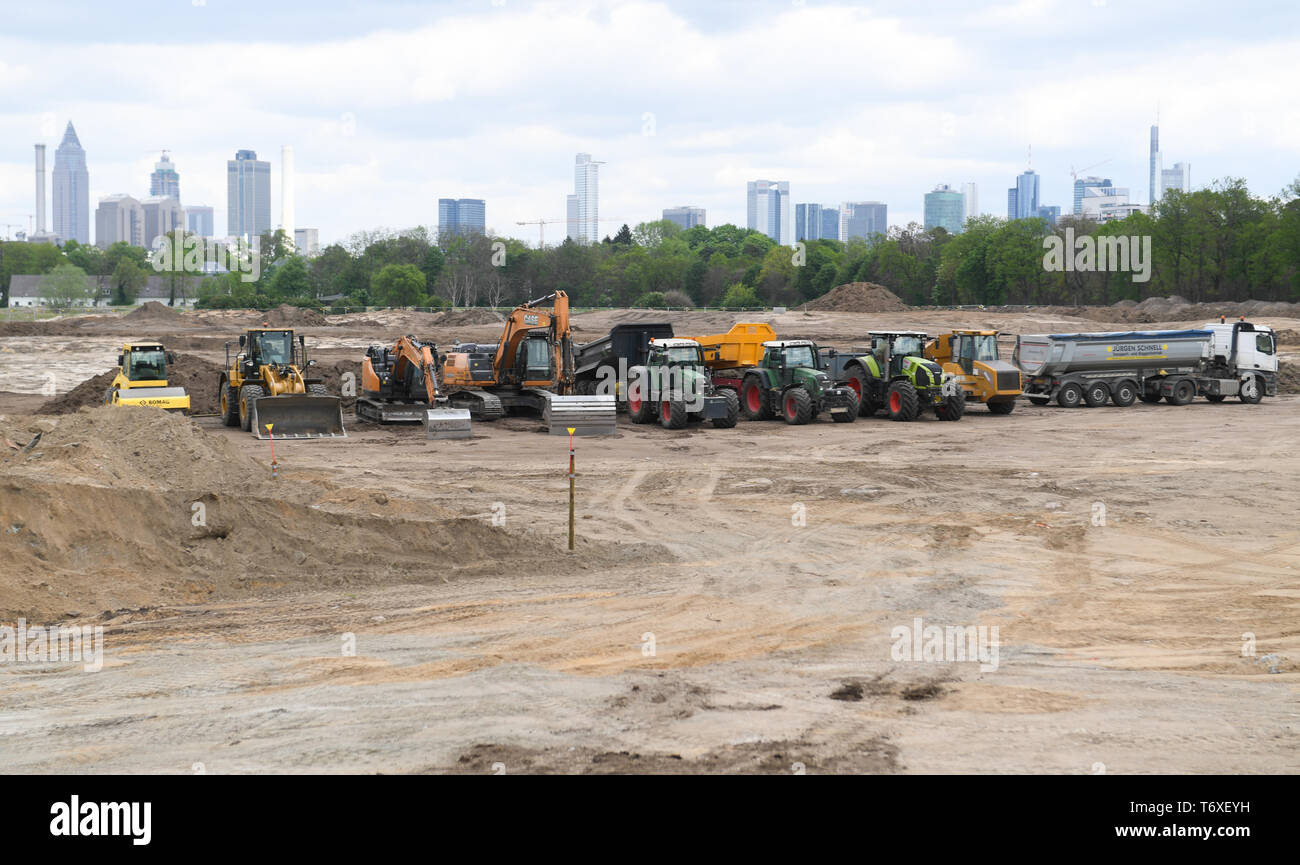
[104, 306, 1278, 438]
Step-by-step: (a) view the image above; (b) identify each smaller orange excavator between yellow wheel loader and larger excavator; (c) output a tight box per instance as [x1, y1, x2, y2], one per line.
[355, 336, 469, 438]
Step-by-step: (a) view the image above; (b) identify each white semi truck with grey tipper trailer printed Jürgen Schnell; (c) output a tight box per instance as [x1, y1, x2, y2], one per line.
[1011, 320, 1278, 408]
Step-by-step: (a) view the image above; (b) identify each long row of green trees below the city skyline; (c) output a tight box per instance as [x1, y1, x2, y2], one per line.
[0, 178, 1300, 308]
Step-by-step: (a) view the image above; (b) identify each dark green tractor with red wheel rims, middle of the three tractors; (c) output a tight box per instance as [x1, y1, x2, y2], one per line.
[738, 339, 858, 424]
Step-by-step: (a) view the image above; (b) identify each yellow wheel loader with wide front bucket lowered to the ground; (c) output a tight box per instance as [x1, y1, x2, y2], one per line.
[218, 328, 347, 438]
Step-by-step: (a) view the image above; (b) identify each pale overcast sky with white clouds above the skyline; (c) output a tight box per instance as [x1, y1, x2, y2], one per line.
[0, 0, 1300, 243]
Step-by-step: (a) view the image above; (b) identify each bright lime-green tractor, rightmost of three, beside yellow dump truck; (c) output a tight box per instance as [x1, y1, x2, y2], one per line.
[827, 330, 966, 420]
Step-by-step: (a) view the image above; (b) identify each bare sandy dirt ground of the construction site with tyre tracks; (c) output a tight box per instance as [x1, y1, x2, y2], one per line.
[0, 306, 1300, 774]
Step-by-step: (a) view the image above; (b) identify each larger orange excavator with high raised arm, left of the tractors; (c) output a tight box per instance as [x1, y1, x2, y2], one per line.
[442, 291, 616, 436]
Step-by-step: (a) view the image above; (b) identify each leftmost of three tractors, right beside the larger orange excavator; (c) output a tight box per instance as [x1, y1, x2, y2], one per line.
[628, 337, 740, 429]
